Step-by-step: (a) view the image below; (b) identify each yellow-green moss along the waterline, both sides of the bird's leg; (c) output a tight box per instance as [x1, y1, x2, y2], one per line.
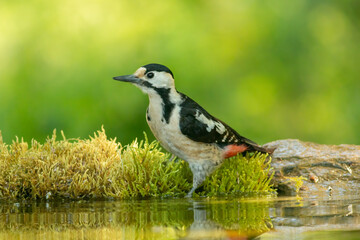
[0, 128, 273, 199]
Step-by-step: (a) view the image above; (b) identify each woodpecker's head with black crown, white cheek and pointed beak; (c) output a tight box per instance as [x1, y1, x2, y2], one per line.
[113, 63, 175, 94]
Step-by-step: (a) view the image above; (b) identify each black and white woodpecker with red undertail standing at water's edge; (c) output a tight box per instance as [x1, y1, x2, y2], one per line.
[113, 63, 268, 197]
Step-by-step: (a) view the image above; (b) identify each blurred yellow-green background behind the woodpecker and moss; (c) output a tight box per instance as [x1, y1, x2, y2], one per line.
[0, 0, 360, 144]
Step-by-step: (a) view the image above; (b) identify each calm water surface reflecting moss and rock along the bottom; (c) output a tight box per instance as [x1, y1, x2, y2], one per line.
[0, 195, 360, 240]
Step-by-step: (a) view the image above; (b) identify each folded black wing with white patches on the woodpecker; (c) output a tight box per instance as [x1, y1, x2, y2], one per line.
[180, 96, 259, 147]
